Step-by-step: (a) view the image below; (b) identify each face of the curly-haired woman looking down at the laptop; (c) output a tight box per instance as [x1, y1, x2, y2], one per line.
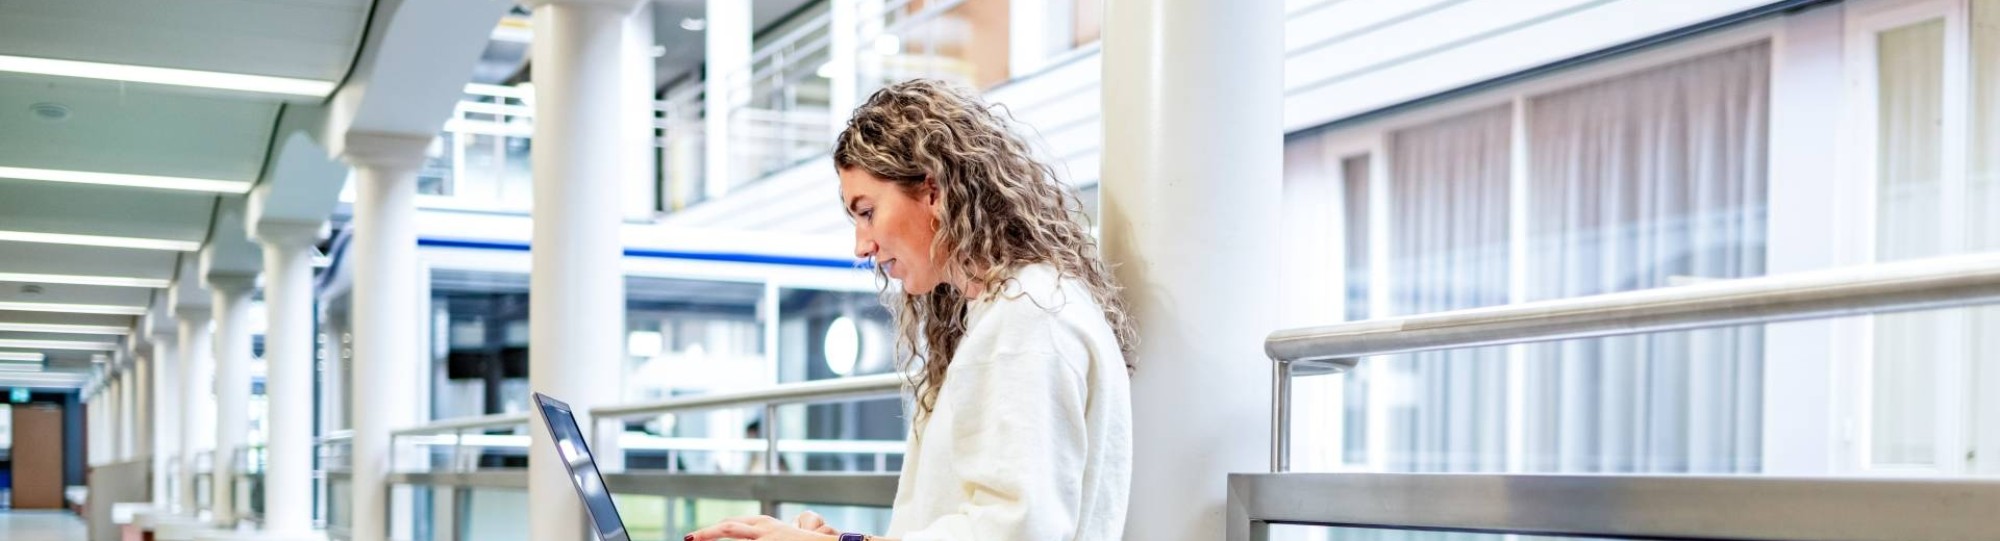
[840, 166, 944, 295]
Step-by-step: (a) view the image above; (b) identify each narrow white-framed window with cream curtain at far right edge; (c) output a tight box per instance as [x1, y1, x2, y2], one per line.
[1842, 0, 2000, 473]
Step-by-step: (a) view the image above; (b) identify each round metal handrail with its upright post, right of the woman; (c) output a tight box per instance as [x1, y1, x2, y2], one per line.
[1264, 252, 2000, 471]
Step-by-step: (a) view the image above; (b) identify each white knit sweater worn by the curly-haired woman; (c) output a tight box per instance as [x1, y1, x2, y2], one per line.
[888, 264, 1132, 541]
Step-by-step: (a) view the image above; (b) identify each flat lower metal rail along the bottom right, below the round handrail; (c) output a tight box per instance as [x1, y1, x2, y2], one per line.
[1224, 473, 2000, 541]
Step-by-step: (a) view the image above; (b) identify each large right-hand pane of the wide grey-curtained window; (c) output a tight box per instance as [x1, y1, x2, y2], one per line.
[1524, 44, 1770, 473]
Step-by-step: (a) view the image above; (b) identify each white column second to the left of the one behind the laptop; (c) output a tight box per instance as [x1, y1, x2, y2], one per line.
[254, 222, 320, 533]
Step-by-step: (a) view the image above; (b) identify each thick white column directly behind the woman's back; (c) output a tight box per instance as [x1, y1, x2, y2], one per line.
[1104, 0, 1284, 539]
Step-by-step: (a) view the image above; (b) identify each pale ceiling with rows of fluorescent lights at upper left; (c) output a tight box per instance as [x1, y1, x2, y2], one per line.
[0, 0, 374, 387]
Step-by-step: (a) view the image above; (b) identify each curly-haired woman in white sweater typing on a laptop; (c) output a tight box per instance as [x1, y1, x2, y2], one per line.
[688, 80, 1132, 541]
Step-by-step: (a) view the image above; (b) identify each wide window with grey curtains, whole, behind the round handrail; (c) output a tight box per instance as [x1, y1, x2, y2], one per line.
[1284, 40, 1770, 473]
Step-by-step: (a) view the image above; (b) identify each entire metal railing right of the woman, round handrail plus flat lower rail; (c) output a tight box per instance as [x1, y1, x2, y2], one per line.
[1228, 252, 2000, 541]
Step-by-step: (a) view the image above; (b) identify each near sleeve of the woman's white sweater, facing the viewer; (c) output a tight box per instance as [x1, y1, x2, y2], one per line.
[902, 329, 1088, 541]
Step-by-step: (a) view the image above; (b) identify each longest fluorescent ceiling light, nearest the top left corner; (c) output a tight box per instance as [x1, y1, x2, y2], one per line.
[0, 54, 334, 98]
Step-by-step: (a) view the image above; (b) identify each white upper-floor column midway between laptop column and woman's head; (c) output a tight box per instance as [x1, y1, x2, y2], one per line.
[704, 0, 754, 198]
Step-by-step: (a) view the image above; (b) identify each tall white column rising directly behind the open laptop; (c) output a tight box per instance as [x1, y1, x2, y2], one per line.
[528, 0, 632, 539]
